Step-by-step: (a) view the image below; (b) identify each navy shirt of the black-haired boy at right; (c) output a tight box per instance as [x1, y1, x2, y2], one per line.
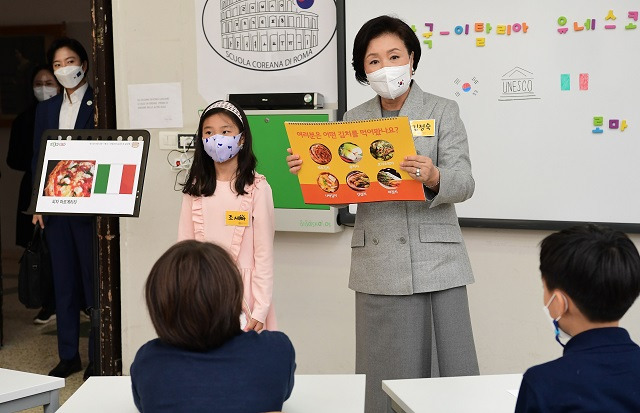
[516, 327, 640, 413]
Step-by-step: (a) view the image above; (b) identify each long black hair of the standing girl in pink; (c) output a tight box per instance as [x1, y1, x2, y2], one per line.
[182, 101, 257, 196]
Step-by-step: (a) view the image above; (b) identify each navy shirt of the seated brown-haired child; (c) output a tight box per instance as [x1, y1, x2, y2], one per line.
[131, 331, 296, 413]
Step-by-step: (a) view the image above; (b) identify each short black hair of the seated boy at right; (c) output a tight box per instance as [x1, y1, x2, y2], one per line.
[540, 224, 640, 322]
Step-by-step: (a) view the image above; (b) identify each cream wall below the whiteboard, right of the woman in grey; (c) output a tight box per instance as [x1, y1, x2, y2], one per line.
[463, 228, 640, 374]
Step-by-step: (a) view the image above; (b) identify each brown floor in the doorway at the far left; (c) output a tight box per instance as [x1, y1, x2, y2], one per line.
[0, 249, 89, 413]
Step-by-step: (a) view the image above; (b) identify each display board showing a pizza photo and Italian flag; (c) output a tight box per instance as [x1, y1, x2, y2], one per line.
[31, 130, 149, 216]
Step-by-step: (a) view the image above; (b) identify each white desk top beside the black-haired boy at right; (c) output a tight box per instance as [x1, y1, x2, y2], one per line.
[382, 374, 522, 413]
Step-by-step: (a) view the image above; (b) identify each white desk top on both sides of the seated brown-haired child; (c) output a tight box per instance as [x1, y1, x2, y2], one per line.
[58, 374, 365, 413]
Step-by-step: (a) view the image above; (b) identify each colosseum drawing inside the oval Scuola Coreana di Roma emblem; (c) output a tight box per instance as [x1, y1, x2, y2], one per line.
[220, 0, 318, 52]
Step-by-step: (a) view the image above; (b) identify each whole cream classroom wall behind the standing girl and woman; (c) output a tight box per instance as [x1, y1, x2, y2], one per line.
[113, 0, 640, 374]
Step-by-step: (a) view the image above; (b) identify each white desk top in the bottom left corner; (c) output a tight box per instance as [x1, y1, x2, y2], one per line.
[0, 369, 64, 403]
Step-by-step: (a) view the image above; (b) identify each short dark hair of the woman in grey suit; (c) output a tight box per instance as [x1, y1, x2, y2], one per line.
[351, 16, 422, 85]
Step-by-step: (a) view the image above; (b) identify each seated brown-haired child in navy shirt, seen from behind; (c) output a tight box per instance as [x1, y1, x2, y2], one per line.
[131, 240, 296, 413]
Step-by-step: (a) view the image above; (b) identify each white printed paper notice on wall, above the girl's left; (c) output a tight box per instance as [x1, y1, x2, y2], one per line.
[129, 83, 183, 129]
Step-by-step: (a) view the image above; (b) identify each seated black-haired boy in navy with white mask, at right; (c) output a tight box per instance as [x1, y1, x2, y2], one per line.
[516, 225, 640, 413]
